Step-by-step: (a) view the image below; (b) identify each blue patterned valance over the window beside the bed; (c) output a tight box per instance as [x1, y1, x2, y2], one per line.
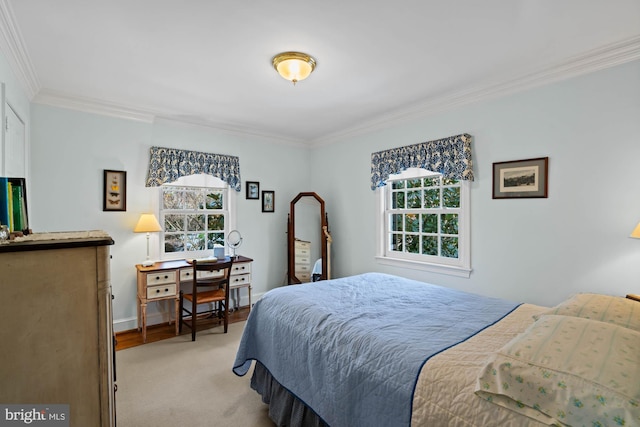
[371, 133, 473, 190]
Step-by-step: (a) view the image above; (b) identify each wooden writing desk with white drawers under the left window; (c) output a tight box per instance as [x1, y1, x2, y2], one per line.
[136, 255, 253, 342]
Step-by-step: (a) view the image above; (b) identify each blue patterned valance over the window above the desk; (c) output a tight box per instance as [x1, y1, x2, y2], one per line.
[146, 147, 242, 191]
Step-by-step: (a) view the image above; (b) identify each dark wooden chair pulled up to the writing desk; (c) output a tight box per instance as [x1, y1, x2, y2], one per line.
[179, 260, 233, 341]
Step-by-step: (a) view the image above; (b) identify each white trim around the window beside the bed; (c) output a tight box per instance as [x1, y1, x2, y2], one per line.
[375, 168, 472, 278]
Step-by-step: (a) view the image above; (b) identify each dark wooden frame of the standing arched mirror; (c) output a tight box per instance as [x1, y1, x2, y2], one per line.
[287, 192, 331, 285]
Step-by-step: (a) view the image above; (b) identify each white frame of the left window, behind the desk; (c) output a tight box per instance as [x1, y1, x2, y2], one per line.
[155, 174, 237, 261]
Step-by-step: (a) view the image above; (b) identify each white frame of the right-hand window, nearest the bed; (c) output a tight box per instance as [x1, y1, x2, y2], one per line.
[375, 168, 472, 278]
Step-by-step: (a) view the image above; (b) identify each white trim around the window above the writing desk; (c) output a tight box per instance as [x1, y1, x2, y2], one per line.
[151, 174, 238, 261]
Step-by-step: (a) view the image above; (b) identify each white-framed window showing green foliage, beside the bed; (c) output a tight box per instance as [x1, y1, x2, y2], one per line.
[377, 168, 471, 277]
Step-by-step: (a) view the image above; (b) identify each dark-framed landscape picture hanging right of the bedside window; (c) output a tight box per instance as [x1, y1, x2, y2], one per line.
[493, 157, 549, 199]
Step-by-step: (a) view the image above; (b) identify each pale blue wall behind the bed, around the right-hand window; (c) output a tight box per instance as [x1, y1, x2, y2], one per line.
[312, 61, 640, 305]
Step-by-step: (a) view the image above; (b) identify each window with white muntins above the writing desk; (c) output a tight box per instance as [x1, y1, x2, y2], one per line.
[159, 178, 235, 259]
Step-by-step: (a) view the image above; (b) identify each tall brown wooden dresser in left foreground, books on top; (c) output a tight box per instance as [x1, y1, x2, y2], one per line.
[0, 233, 115, 427]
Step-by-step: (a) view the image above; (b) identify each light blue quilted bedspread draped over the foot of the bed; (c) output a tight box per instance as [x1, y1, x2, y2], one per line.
[233, 273, 517, 427]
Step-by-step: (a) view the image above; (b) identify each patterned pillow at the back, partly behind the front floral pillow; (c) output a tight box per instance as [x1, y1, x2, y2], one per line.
[534, 293, 640, 331]
